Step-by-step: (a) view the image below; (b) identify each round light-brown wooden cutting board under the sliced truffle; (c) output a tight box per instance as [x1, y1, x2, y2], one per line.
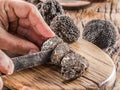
[3, 39, 116, 90]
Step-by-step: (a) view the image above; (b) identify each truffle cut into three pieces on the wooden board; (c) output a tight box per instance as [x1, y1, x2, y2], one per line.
[41, 36, 89, 81]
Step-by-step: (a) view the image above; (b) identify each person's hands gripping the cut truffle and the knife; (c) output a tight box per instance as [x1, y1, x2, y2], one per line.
[0, 0, 55, 86]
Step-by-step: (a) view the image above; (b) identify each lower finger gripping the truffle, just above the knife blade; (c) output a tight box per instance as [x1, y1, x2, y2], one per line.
[0, 28, 39, 54]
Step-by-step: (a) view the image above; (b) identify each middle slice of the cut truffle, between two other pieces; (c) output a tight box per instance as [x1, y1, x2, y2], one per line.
[51, 43, 71, 66]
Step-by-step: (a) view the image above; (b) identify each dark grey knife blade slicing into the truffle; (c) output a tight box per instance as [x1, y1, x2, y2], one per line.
[12, 50, 52, 72]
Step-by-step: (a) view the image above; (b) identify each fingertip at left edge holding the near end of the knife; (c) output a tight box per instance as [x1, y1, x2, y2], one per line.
[0, 50, 14, 75]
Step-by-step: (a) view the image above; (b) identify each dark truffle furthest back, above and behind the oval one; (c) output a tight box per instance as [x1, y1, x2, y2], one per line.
[39, 0, 64, 25]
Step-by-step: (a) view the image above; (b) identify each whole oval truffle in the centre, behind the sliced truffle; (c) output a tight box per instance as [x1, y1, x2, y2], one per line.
[50, 15, 80, 43]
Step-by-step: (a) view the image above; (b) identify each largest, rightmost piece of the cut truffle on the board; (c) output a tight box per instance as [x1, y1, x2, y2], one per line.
[61, 52, 89, 81]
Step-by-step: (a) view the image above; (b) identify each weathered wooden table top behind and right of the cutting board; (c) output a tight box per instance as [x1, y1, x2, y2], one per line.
[66, 0, 120, 90]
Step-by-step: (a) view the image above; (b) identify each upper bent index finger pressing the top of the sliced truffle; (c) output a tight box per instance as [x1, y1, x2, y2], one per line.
[5, 0, 55, 42]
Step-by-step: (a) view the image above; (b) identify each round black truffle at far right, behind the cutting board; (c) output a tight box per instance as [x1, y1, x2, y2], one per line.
[83, 19, 116, 49]
